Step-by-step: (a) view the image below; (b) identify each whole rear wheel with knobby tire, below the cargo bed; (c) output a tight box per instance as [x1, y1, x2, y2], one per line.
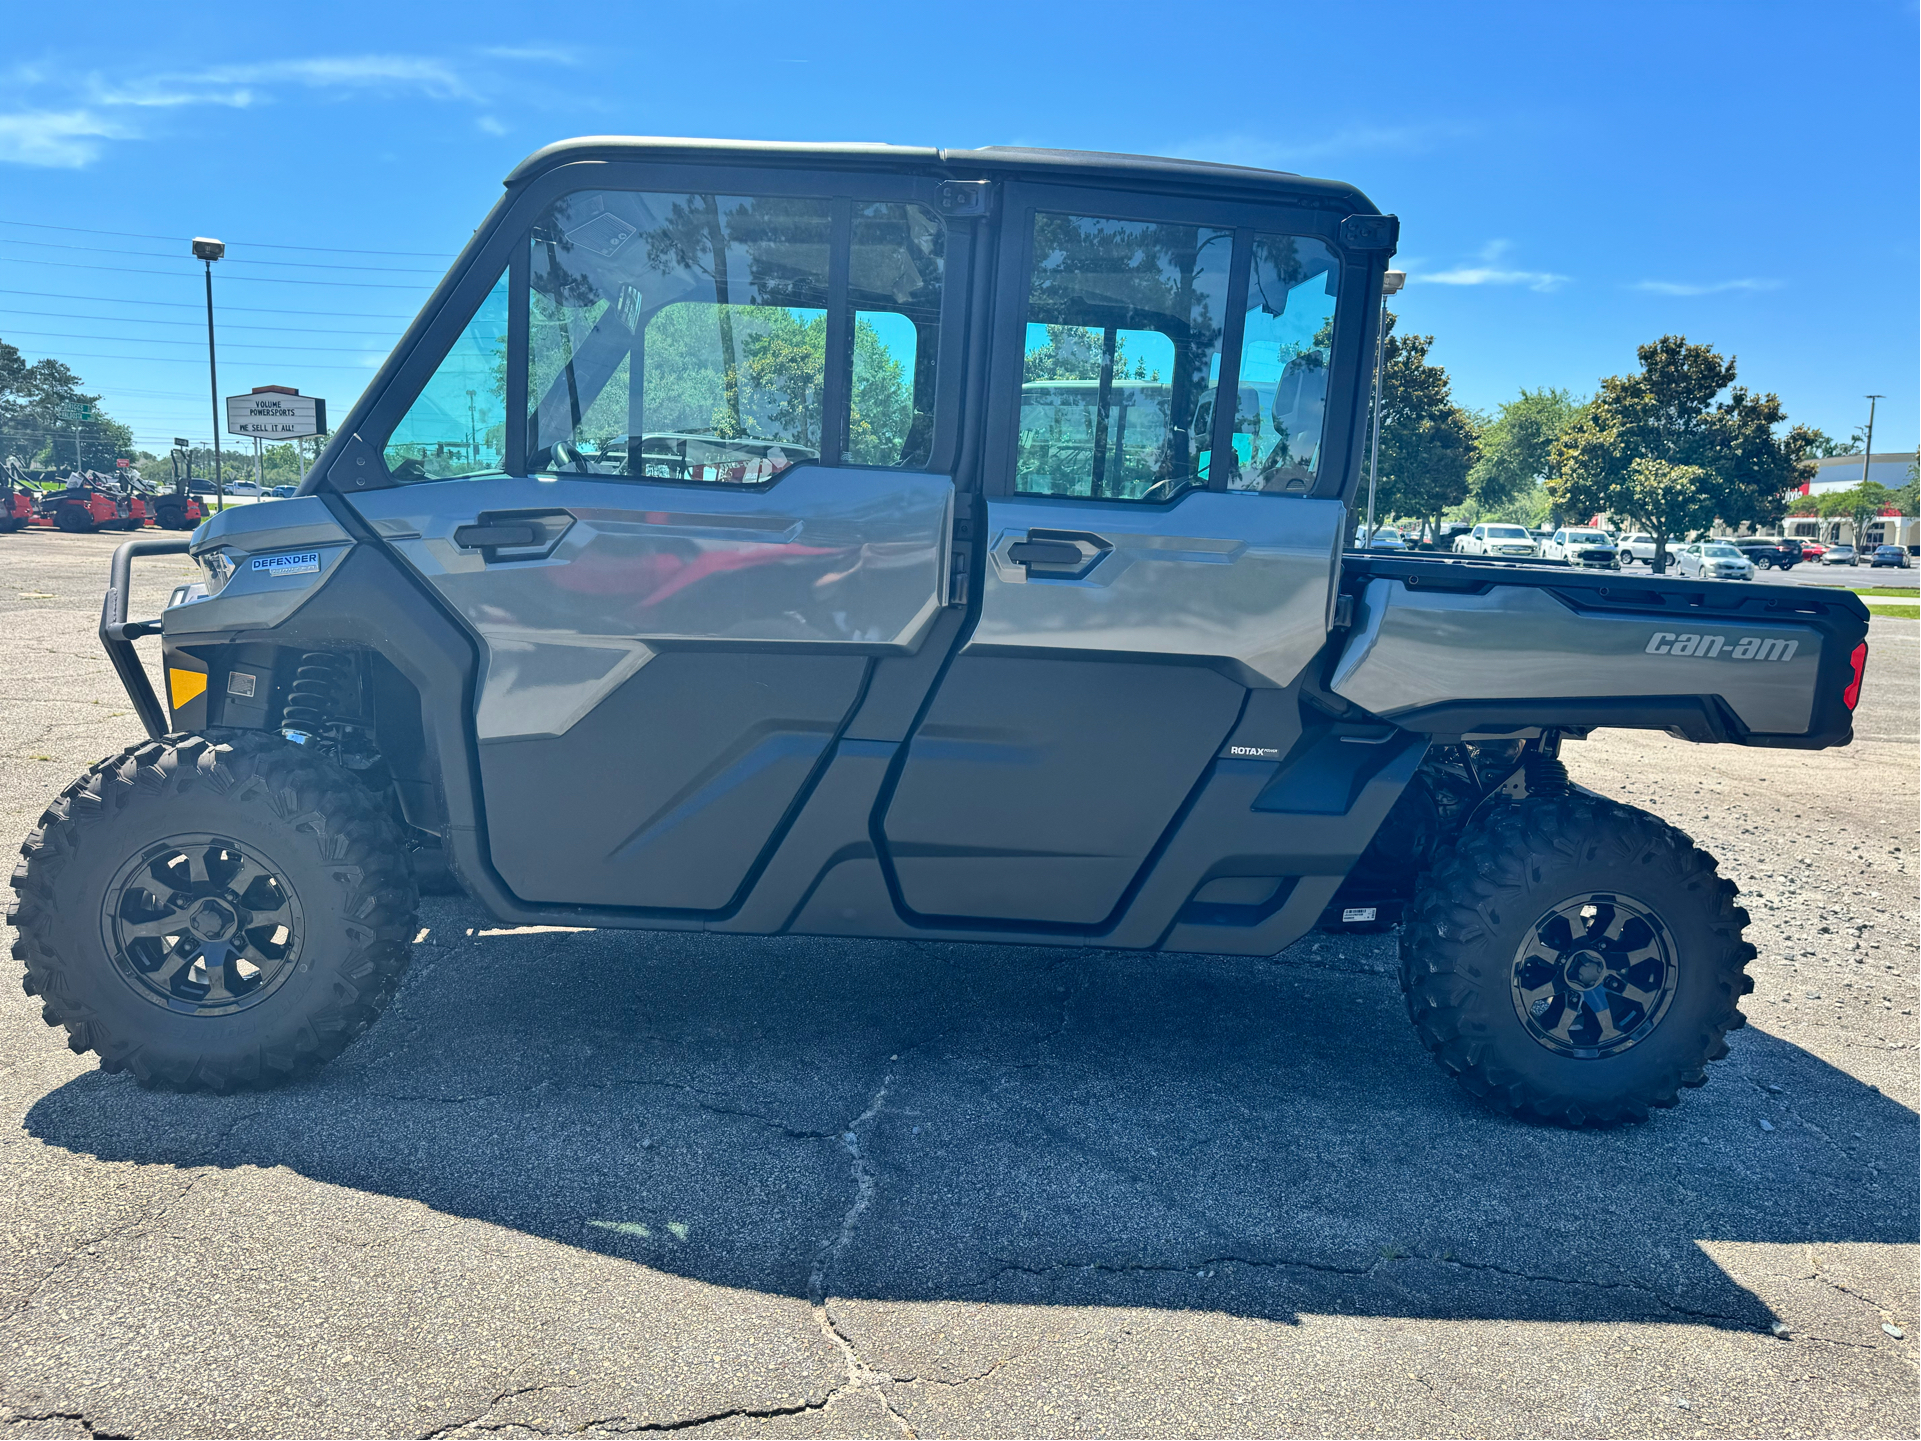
[1400, 794, 1756, 1126]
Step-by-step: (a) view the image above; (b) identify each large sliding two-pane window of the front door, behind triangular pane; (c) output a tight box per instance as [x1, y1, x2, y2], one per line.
[526, 190, 945, 484]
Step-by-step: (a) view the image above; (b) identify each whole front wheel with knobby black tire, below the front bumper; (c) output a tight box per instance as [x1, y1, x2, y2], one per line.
[8, 732, 417, 1091]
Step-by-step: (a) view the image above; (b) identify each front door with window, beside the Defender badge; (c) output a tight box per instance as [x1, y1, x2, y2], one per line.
[353, 165, 955, 913]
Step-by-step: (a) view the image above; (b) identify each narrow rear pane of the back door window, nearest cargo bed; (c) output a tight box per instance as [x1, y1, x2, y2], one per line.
[1228, 234, 1341, 494]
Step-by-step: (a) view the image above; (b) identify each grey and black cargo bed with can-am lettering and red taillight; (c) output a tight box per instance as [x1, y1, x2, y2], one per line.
[1327, 557, 1867, 747]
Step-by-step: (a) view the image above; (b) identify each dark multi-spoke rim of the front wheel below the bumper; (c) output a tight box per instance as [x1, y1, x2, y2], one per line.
[100, 832, 305, 1016]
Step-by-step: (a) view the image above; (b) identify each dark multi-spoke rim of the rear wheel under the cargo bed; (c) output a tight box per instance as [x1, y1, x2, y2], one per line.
[1514, 891, 1677, 1061]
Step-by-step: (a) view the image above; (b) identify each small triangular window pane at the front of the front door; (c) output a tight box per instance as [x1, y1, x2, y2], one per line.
[382, 265, 507, 482]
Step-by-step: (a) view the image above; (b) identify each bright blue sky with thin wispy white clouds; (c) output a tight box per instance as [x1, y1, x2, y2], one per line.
[0, 0, 1917, 452]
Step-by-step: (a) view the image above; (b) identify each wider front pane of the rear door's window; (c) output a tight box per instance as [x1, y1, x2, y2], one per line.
[1014, 211, 1233, 501]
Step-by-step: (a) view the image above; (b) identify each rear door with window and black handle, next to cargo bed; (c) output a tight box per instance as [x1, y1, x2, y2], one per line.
[884, 186, 1360, 930]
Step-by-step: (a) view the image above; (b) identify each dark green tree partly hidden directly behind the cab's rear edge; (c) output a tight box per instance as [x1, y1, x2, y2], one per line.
[1377, 313, 1481, 545]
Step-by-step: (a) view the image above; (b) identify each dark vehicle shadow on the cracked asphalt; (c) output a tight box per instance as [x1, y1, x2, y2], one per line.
[27, 901, 1921, 1330]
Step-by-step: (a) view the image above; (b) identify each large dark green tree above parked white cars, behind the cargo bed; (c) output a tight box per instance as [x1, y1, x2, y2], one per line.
[1548, 334, 1815, 569]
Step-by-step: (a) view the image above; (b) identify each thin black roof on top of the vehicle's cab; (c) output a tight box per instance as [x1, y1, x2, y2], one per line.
[505, 134, 1379, 215]
